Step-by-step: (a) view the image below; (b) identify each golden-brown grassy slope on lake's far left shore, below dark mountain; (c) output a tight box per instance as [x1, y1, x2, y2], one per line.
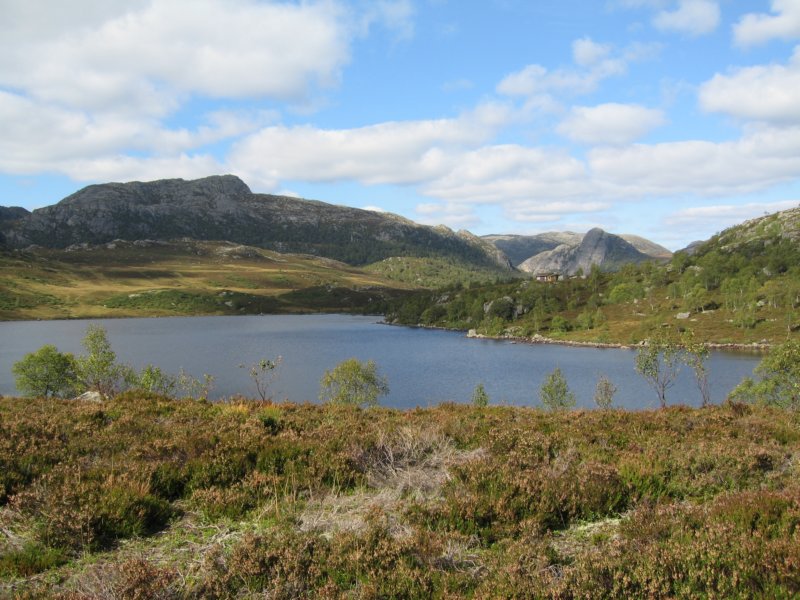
[0, 241, 408, 319]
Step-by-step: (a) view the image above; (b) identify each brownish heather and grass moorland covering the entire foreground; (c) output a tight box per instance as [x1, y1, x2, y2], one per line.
[0, 392, 800, 598]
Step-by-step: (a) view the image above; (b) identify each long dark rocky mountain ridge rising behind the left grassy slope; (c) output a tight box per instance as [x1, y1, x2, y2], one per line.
[0, 175, 510, 269]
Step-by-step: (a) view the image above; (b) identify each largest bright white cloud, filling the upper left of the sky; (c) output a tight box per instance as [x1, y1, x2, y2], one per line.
[0, 0, 349, 112]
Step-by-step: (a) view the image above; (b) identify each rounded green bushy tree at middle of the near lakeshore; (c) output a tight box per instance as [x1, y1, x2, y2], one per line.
[319, 358, 389, 406]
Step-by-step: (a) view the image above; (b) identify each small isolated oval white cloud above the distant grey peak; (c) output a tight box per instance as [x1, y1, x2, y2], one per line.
[556, 103, 665, 144]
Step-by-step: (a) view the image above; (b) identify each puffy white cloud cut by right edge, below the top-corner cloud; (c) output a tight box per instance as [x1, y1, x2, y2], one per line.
[699, 47, 800, 123]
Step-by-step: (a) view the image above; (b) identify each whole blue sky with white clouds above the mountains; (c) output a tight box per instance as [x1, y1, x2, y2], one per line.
[0, 0, 800, 250]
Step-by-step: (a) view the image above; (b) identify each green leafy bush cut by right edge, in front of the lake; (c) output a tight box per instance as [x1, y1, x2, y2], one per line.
[731, 341, 800, 410]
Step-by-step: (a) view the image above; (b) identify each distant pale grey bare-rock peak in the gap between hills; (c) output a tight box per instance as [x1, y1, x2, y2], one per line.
[518, 228, 653, 275]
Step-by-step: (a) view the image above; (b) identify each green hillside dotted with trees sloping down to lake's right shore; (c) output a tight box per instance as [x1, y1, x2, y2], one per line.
[391, 209, 800, 344]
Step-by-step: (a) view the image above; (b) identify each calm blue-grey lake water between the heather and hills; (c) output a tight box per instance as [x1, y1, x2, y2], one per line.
[0, 315, 760, 409]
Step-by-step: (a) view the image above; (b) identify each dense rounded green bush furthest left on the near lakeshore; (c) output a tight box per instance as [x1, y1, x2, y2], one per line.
[11, 344, 77, 398]
